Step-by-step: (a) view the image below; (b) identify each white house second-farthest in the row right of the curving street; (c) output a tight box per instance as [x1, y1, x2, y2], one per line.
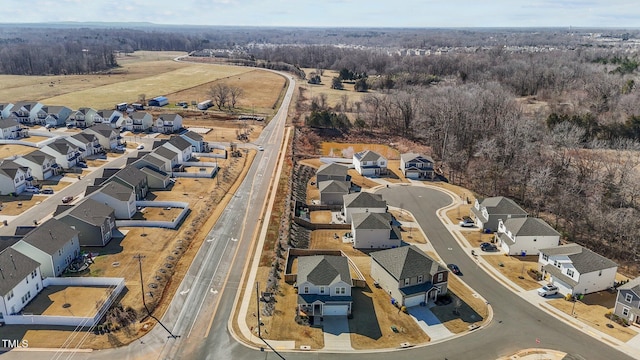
[495, 217, 560, 255]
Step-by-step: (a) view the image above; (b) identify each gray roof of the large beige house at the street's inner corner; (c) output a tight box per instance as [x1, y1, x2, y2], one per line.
[369, 245, 445, 281]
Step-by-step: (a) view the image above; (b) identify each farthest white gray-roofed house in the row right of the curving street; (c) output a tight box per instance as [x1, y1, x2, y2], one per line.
[470, 196, 527, 231]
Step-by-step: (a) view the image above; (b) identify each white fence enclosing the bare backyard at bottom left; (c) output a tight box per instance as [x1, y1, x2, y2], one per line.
[4, 277, 125, 327]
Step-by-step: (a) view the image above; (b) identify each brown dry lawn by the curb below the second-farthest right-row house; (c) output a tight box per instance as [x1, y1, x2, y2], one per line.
[483, 254, 540, 290]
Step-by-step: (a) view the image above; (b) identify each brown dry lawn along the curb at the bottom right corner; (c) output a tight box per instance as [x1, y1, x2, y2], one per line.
[548, 291, 638, 342]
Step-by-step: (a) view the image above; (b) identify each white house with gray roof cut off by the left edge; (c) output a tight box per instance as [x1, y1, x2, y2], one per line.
[0, 247, 44, 322]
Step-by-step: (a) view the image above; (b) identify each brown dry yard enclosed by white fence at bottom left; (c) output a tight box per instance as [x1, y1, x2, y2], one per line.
[23, 286, 113, 316]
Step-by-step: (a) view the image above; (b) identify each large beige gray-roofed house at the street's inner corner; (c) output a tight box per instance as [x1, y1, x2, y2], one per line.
[370, 245, 448, 307]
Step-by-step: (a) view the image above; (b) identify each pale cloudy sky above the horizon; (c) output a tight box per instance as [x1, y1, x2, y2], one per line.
[0, 0, 640, 28]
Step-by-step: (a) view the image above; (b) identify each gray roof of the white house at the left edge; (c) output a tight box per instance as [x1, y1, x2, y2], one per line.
[0, 248, 40, 296]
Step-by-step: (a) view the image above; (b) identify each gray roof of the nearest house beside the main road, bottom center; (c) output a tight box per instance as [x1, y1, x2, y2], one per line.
[297, 255, 351, 285]
